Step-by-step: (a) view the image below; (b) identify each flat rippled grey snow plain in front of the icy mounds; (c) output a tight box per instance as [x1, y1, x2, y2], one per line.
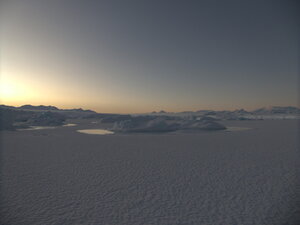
[0, 120, 300, 225]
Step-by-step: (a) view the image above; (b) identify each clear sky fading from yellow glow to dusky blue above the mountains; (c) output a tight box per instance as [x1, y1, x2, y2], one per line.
[0, 0, 299, 113]
